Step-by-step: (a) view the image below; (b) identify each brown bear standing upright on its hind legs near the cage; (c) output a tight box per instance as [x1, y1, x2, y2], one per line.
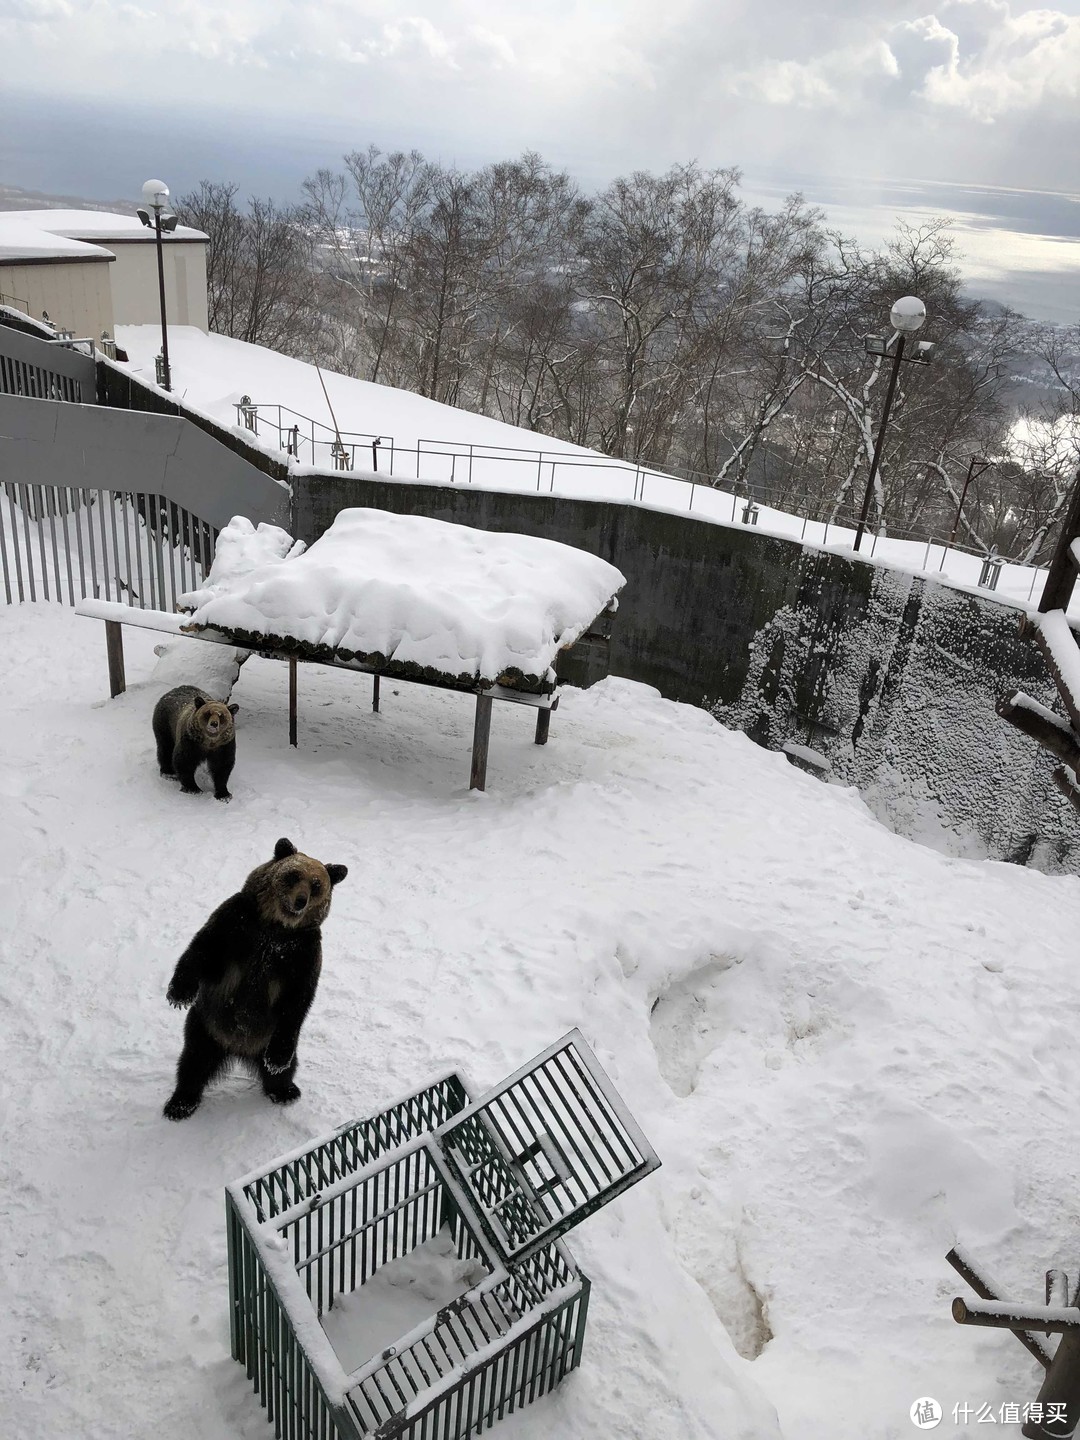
[164, 840, 348, 1120]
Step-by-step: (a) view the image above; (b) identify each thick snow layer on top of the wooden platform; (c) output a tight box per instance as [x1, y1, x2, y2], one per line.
[180, 510, 626, 684]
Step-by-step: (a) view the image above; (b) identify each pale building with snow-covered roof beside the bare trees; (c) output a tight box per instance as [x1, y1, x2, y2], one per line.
[0, 210, 209, 340]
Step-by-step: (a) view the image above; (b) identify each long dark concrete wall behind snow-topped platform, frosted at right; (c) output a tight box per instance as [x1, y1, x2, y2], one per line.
[292, 472, 1080, 871]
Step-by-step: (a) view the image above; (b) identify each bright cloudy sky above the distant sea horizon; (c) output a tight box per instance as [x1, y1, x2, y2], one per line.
[0, 0, 1080, 197]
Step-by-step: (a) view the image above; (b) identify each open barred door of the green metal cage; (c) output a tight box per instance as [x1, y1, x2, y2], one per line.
[435, 1030, 660, 1264]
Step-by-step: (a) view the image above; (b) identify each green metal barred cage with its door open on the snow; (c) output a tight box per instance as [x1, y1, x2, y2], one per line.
[226, 1031, 660, 1440]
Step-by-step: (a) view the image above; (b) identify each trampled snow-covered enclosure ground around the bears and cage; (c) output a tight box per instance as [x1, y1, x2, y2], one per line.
[0, 605, 1080, 1440]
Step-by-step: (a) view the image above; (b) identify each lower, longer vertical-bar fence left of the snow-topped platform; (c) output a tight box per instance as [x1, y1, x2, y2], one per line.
[0, 481, 217, 611]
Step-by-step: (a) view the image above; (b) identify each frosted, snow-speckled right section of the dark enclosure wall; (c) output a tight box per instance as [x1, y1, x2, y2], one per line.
[711, 552, 1080, 873]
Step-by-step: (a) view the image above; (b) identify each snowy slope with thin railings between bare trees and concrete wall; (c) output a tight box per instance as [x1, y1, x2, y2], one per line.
[117, 325, 1080, 615]
